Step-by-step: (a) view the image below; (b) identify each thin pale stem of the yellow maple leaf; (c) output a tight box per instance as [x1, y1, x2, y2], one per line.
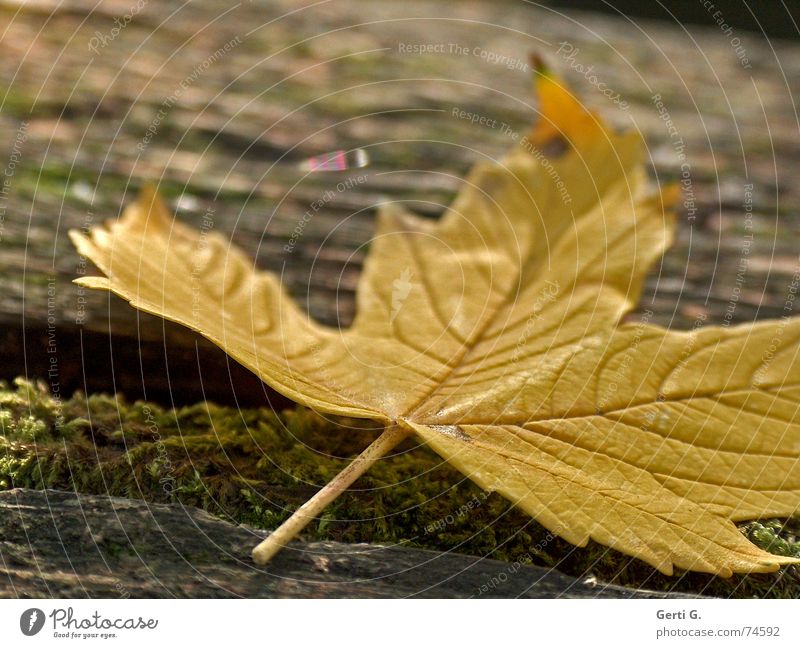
[253, 425, 411, 565]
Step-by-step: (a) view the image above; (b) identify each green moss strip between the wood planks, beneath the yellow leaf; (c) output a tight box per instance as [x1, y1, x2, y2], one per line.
[0, 379, 800, 598]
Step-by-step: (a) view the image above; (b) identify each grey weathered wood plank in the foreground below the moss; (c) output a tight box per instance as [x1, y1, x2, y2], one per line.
[0, 488, 691, 598]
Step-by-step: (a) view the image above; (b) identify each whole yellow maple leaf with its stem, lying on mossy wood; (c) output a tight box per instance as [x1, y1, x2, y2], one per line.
[71, 64, 800, 576]
